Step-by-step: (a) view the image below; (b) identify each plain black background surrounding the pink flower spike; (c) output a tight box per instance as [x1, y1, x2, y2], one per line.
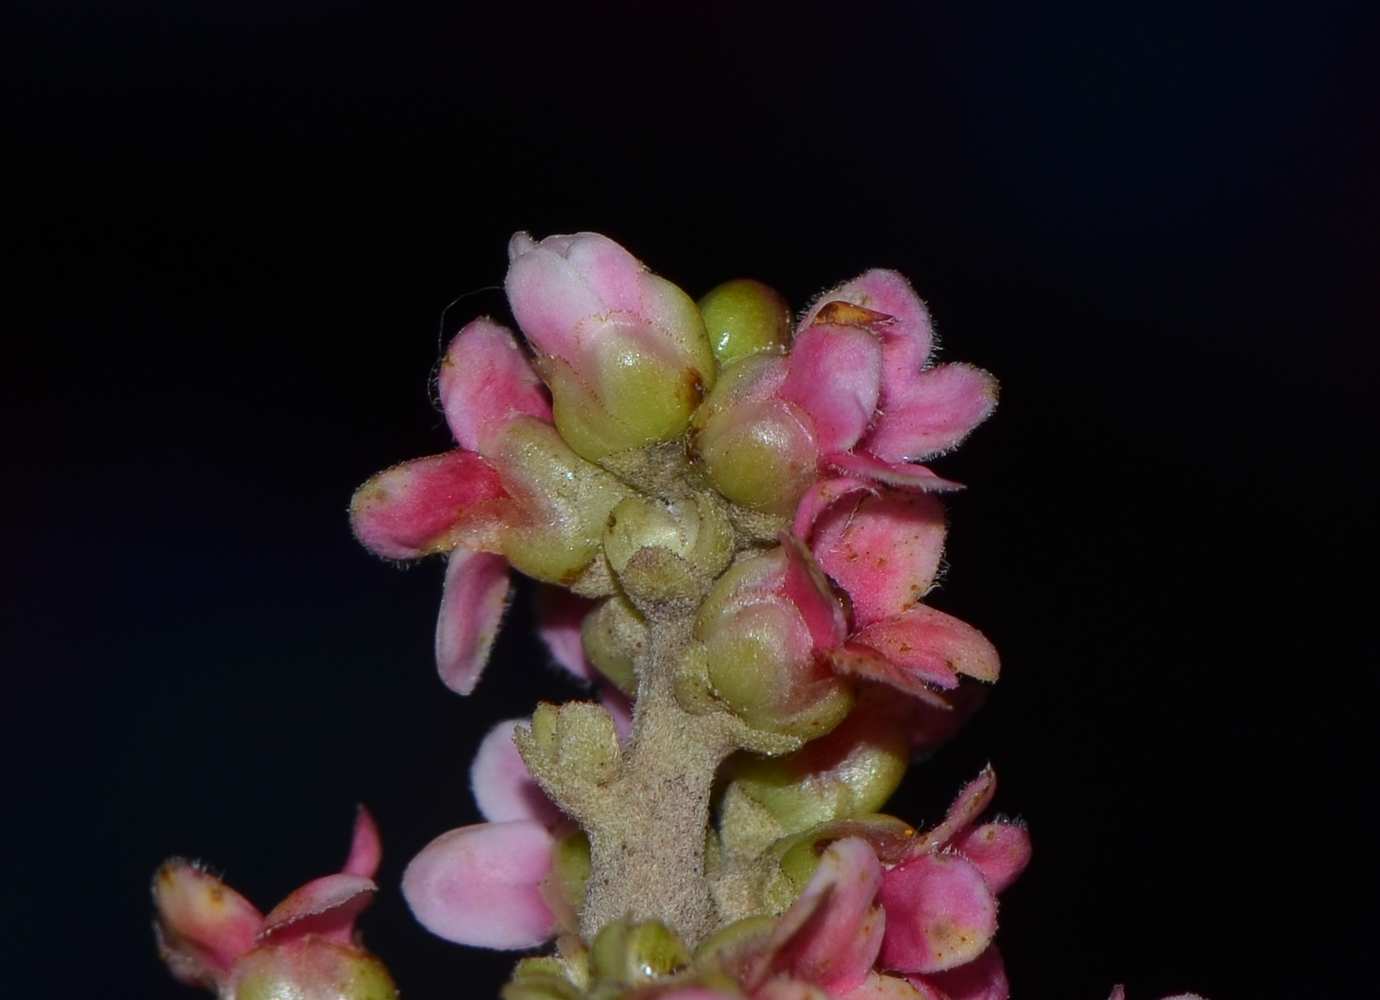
[0, 0, 1380, 1000]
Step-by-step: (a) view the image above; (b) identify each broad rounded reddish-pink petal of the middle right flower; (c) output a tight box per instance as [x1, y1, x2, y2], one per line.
[810, 492, 944, 626]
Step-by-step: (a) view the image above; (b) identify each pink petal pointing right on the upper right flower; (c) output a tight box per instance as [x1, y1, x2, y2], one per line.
[861, 364, 996, 462]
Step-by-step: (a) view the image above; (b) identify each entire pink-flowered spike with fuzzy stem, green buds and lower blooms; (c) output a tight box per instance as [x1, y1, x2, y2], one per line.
[155, 233, 1208, 1000]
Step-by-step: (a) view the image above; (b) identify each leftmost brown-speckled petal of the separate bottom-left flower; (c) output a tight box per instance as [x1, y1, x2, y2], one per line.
[153, 858, 264, 983]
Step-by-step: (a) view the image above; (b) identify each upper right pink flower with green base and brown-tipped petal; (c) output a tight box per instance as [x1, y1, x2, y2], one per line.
[696, 270, 996, 513]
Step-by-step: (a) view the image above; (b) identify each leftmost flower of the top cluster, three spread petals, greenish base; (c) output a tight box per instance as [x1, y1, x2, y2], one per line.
[351, 319, 624, 694]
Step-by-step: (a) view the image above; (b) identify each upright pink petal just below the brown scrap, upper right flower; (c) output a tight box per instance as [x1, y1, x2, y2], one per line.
[780, 326, 882, 452]
